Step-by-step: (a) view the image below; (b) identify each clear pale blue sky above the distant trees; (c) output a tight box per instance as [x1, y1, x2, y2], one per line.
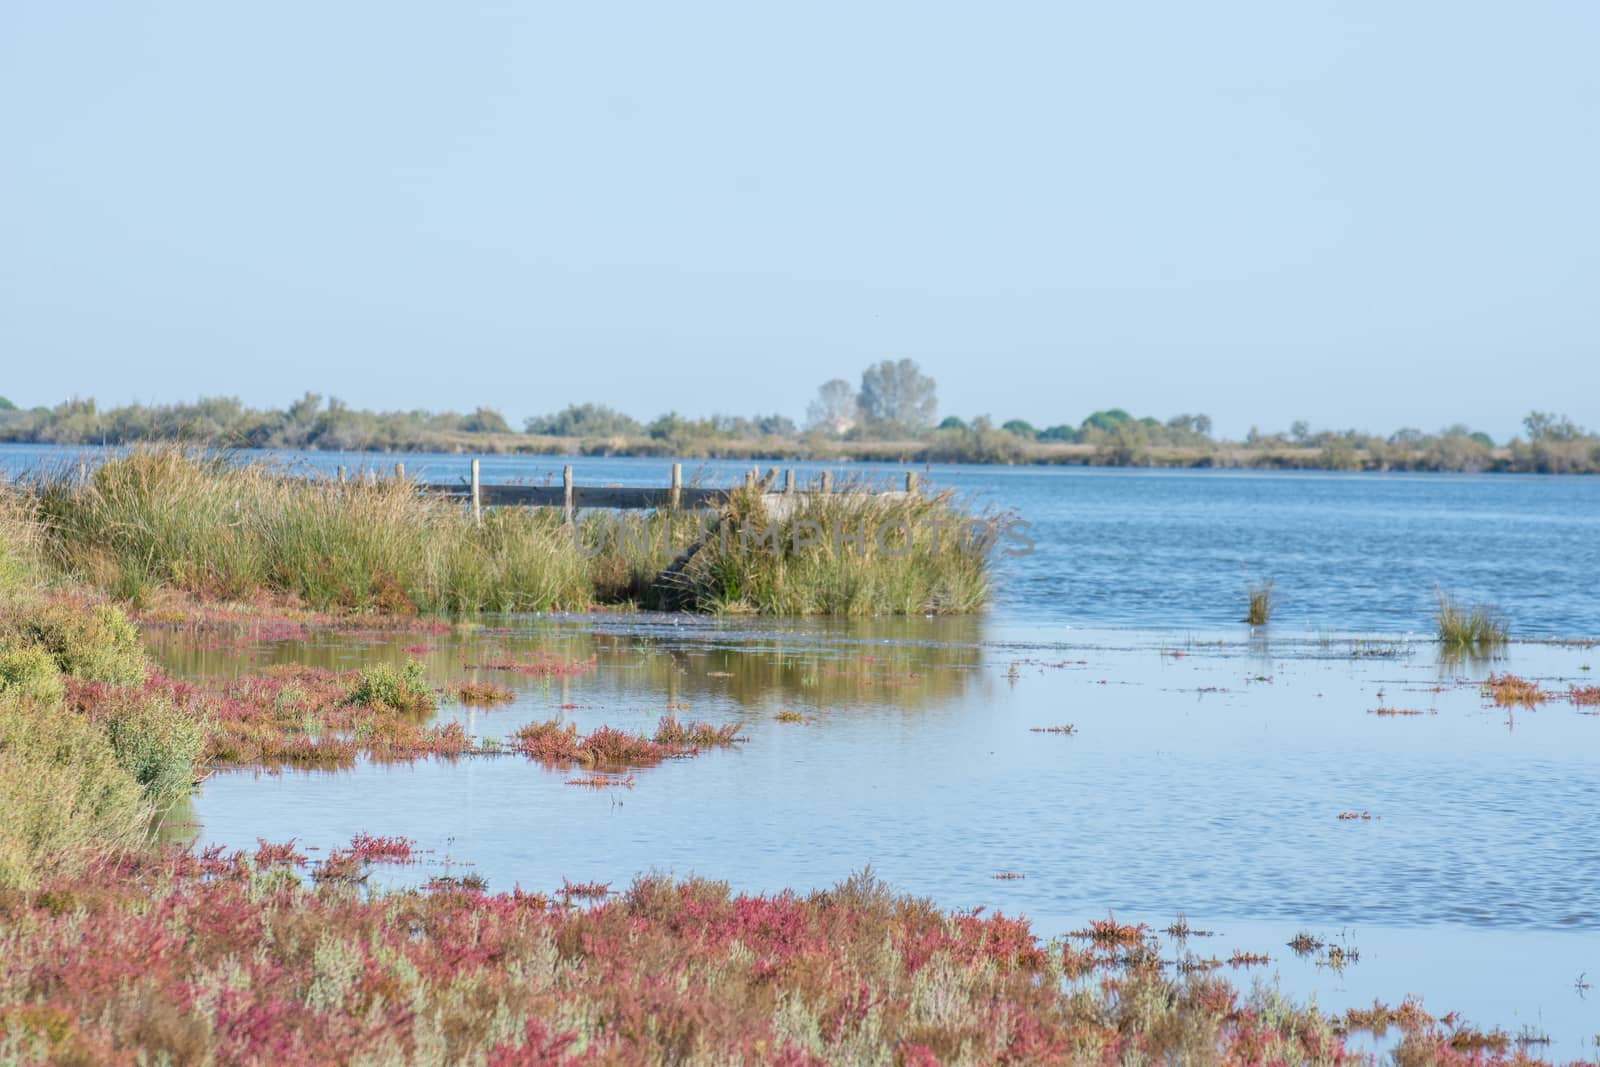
[0, 0, 1600, 438]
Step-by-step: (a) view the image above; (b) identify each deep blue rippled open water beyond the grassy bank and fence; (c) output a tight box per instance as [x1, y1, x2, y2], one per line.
[0, 445, 1600, 637]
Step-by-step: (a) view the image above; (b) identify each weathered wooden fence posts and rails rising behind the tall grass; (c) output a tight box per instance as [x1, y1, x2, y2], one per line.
[329, 459, 917, 522]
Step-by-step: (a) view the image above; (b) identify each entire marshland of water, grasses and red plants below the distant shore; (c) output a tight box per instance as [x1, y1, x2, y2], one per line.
[0, 450, 1600, 1064]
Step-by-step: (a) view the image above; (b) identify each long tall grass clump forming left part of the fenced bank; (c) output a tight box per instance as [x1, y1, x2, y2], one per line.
[34, 448, 592, 614]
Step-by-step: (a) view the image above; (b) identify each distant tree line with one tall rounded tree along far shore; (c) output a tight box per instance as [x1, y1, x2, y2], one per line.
[0, 367, 1600, 474]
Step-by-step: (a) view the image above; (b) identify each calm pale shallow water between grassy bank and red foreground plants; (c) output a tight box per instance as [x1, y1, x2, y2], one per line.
[154, 616, 1600, 1056]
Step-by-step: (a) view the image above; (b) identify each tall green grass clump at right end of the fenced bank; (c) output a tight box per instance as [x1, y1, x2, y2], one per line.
[667, 490, 1000, 616]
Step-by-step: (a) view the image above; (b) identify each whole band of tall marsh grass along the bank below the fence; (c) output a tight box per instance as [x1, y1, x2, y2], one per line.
[25, 446, 1000, 616]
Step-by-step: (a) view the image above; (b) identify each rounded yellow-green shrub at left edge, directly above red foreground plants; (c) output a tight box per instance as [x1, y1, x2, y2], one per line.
[0, 696, 150, 889]
